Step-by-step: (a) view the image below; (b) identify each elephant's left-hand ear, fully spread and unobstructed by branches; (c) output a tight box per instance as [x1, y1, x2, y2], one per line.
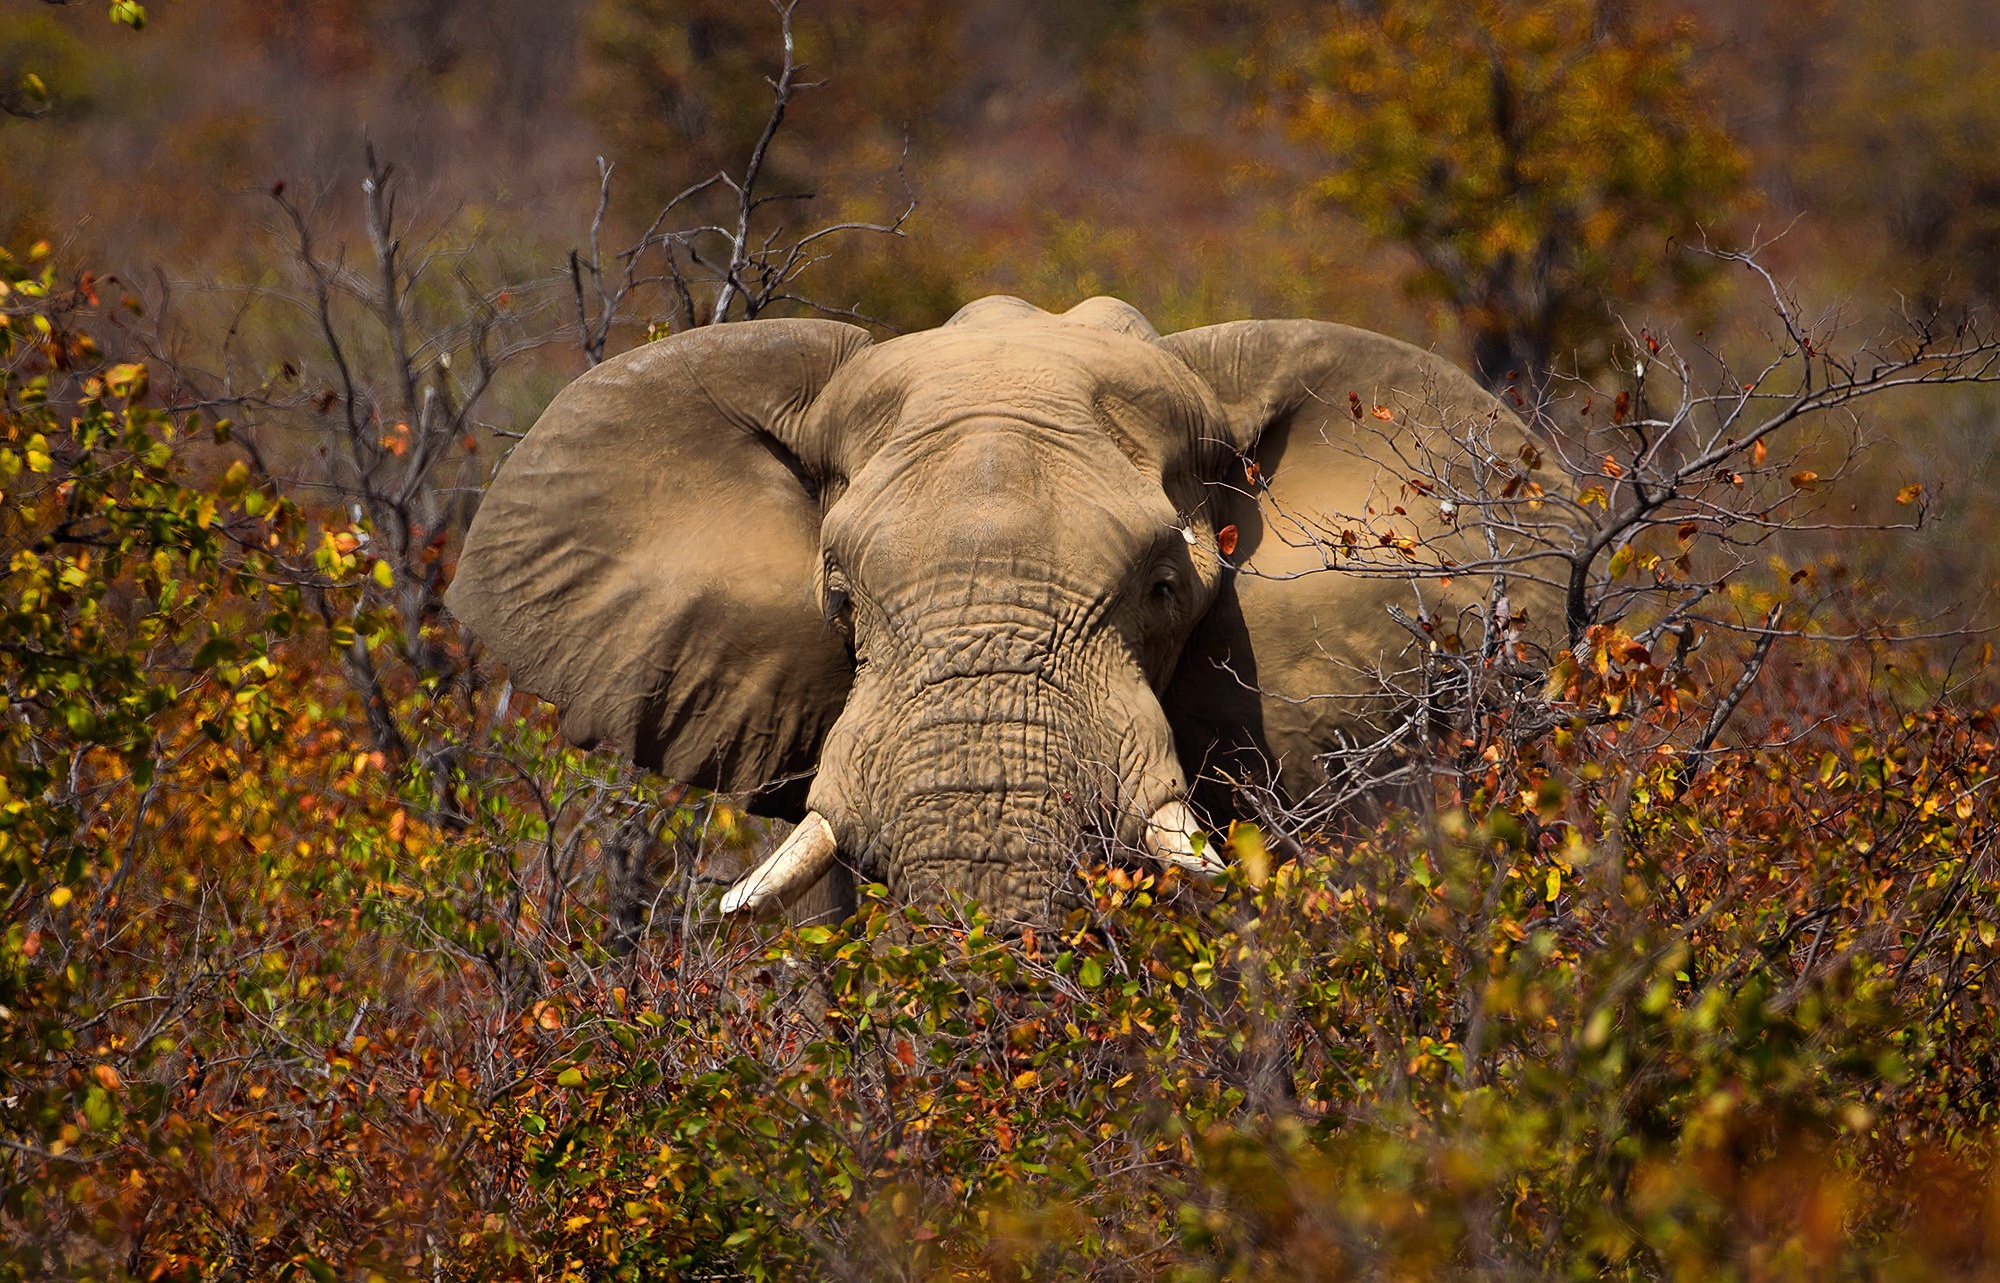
[446, 320, 870, 815]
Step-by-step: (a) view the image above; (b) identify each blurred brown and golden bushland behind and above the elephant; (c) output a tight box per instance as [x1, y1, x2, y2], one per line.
[0, 0, 2000, 618]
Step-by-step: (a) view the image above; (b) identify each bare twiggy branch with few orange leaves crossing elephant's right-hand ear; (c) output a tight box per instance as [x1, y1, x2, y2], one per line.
[1208, 250, 2000, 833]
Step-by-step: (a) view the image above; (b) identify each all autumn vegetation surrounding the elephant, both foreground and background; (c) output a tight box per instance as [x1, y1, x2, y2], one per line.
[0, 0, 2000, 1283]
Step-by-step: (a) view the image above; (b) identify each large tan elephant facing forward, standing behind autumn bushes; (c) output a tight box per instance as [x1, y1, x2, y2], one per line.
[446, 296, 1560, 923]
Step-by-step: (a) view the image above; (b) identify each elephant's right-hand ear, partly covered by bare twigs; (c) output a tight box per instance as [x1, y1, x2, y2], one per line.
[1160, 320, 1560, 797]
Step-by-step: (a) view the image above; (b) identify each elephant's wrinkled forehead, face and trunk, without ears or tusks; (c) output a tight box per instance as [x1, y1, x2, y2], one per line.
[808, 309, 1222, 905]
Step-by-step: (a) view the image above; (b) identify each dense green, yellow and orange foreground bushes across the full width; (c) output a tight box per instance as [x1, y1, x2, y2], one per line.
[0, 258, 2000, 1279]
